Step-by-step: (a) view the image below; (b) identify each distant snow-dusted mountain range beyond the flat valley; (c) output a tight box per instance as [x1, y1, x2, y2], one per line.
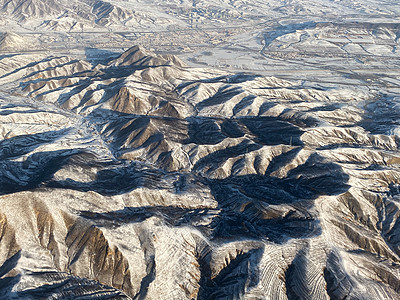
[0, 0, 398, 31]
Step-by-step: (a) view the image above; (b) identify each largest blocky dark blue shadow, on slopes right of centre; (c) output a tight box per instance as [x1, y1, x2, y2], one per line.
[203, 154, 349, 243]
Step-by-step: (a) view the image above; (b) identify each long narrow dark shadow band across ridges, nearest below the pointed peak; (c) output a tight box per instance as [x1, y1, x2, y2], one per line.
[87, 110, 304, 156]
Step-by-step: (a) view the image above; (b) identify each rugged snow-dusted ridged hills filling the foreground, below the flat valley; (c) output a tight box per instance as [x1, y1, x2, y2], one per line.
[0, 43, 400, 299]
